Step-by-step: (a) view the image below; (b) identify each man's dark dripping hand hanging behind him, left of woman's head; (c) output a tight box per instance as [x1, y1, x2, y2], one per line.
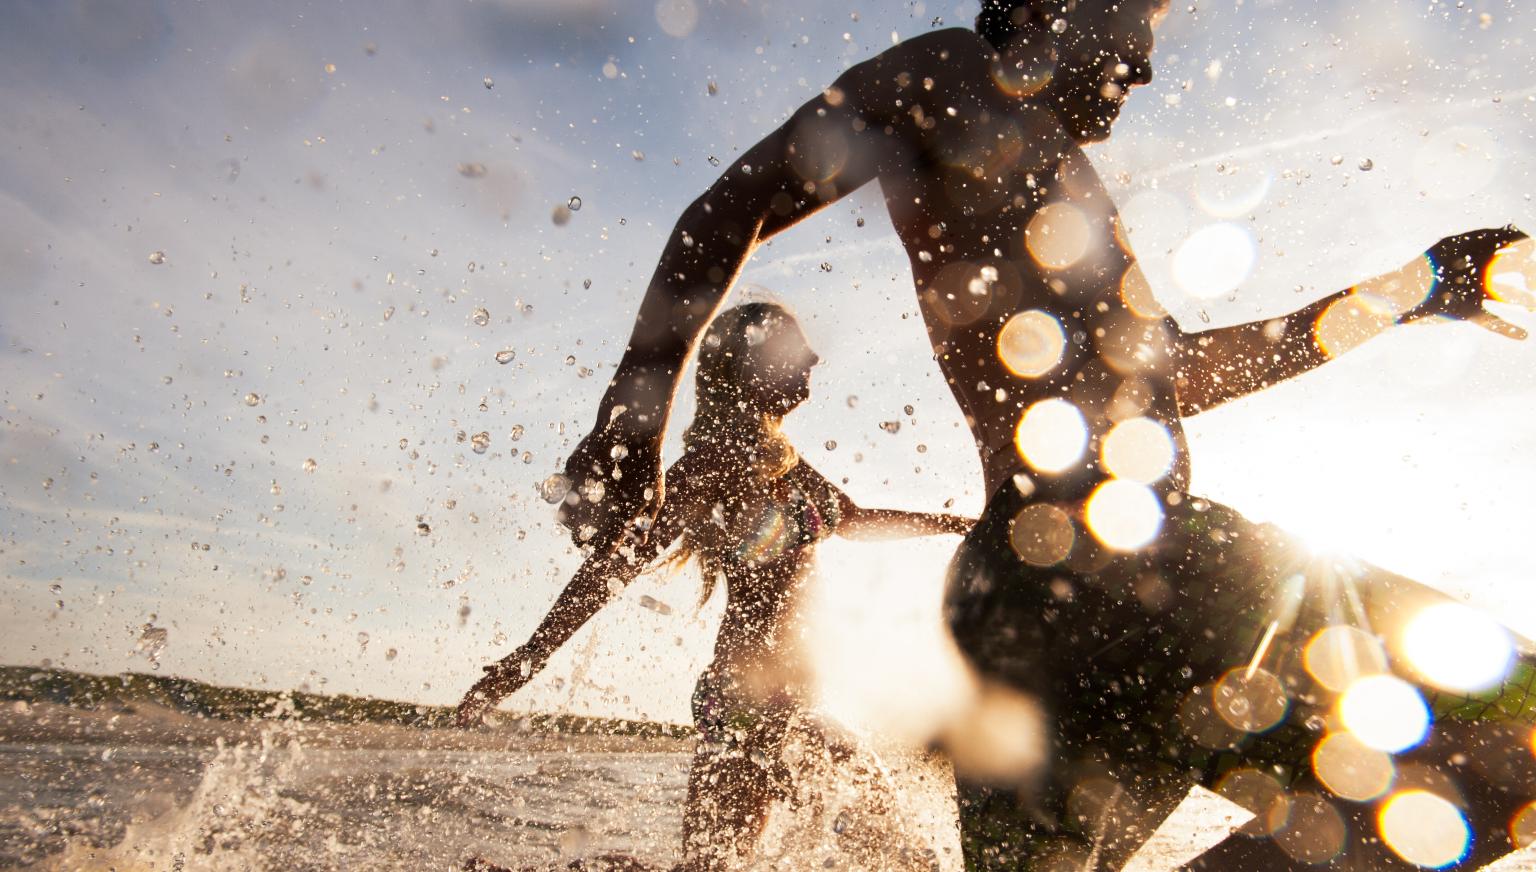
[559, 421, 664, 551]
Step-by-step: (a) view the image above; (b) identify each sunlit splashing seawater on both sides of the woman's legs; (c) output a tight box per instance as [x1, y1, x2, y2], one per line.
[0, 706, 958, 872]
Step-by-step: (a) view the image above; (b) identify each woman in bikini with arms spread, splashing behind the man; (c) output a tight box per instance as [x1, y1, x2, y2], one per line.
[458, 302, 972, 869]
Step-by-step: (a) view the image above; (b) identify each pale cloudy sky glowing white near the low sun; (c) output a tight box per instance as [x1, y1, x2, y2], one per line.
[0, 0, 1536, 722]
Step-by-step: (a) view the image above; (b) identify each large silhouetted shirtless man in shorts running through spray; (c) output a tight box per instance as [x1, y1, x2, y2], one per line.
[562, 0, 1536, 869]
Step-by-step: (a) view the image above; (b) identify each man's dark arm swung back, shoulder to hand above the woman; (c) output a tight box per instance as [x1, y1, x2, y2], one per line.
[561, 49, 889, 550]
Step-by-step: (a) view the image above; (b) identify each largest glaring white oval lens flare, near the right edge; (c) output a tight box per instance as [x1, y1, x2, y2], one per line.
[1402, 602, 1514, 691]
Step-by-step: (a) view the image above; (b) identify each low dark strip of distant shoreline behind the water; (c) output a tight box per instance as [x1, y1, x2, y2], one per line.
[0, 666, 693, 746]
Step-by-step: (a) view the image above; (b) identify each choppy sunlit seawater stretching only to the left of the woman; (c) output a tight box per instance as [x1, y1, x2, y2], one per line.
[0, 745, 688, 870]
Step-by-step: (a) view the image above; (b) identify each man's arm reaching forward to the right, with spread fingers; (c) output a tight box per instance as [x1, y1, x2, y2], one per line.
[1170, 227, 1525, 416]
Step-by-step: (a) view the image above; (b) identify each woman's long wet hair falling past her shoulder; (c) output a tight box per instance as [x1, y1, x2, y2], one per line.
[665, 302, 800, 605]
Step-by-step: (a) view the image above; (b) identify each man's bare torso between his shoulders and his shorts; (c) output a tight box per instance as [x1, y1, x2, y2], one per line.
[835, 29, 1184, 499]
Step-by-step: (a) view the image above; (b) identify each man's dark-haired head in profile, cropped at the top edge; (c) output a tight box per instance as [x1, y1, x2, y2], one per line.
[975, 0, 1169, 143]
